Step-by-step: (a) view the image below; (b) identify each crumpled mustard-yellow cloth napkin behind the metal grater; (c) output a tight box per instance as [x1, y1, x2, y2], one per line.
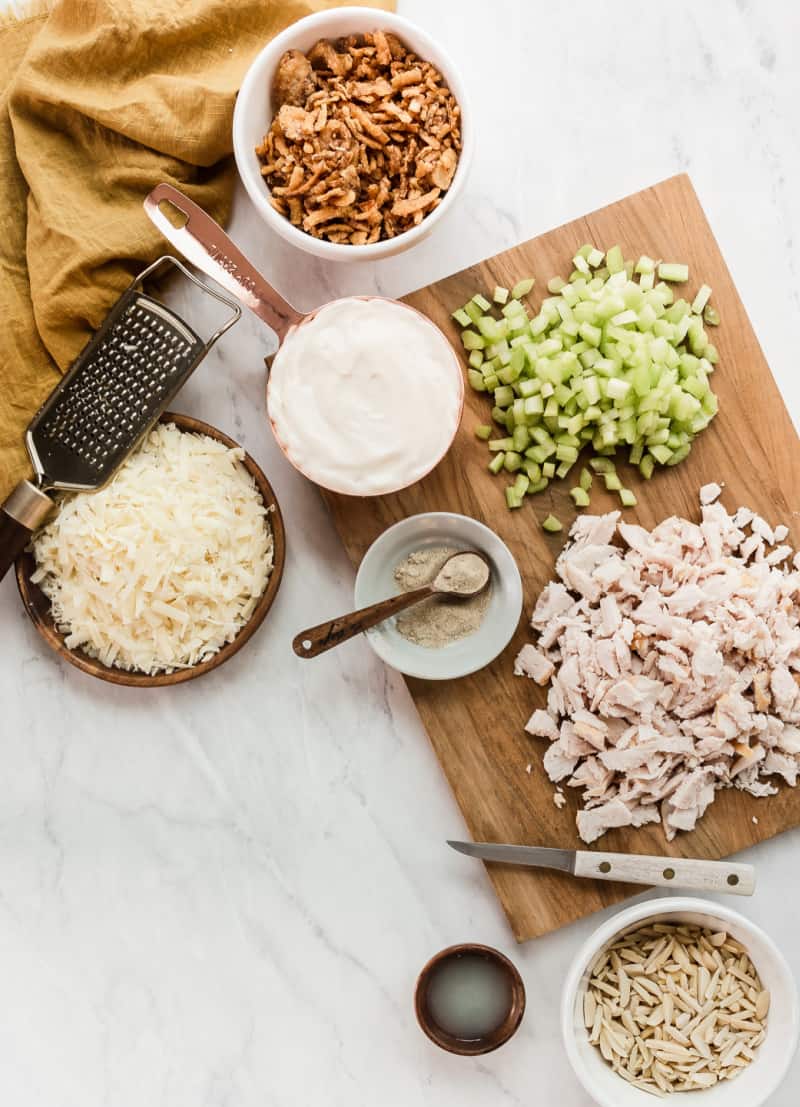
[0, 0, 394, 501]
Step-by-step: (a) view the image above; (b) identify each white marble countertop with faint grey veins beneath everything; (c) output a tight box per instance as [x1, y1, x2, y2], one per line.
[0, 0, 800, 1107]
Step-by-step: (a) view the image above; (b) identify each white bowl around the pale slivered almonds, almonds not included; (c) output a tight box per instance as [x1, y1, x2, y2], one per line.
[561, 897, 800, 1107]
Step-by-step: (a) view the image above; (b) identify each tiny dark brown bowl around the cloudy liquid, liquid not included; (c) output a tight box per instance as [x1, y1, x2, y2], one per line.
[414, 942, 524, 1057]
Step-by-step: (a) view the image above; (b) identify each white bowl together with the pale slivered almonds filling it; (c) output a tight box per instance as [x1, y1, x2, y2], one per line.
[561, 897, 800, 1107]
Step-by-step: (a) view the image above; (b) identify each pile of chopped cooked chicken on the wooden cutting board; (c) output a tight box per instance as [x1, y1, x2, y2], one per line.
[515, 485, 800, 842]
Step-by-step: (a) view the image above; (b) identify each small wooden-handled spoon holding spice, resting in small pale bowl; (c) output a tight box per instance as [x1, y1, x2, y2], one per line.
[292, 550, 491, 658]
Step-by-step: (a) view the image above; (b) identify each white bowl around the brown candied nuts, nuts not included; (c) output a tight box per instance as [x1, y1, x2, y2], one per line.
[233, 8, 475, 261]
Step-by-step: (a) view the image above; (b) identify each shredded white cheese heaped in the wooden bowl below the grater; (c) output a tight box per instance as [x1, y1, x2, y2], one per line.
[31, 424, 272, 673]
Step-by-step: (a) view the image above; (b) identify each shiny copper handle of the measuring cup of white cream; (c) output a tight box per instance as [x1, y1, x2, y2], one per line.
[144, 182, 304, 343]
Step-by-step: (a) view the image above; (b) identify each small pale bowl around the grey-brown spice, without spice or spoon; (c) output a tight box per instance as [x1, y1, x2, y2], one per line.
[355, 511, 522, 681]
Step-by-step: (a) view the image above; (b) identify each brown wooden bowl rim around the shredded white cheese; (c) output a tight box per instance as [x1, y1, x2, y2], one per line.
[14, 412, 285, 689]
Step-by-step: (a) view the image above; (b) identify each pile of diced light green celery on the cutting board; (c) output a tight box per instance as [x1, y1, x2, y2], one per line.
[453, 246, 719, 508]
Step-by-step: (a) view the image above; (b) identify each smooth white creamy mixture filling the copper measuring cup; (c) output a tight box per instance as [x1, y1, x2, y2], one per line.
[269, 299, 464, 496]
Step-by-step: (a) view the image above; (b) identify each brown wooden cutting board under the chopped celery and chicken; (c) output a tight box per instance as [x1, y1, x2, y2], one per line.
[318, 175, 800, 941]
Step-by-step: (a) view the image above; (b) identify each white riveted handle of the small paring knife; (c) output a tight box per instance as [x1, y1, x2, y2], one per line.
[575, 849, 756, 896]
